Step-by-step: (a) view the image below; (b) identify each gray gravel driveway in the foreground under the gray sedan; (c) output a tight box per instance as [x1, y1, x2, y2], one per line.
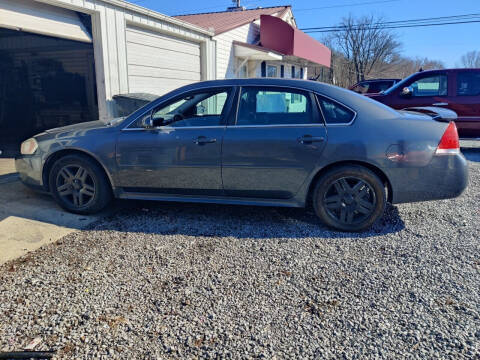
[0, 153, 480, 359]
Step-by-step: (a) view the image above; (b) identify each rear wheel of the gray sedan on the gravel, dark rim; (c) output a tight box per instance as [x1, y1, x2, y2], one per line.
[313, 165, 387, 231]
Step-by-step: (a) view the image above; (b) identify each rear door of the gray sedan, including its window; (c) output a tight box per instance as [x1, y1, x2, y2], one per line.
[222, 86, 327, 199]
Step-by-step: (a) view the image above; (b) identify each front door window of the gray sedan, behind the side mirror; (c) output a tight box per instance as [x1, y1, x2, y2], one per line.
[130, 89, 229, 128]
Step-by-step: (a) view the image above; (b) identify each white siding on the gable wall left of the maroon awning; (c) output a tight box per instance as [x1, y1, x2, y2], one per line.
[214, 23, 260, 79]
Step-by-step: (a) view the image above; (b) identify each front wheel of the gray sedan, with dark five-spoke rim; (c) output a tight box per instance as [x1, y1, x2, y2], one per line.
[49, 154, 112, 214]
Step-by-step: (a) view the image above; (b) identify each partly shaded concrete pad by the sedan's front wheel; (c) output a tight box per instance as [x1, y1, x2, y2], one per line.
[0, 163, 105, 265]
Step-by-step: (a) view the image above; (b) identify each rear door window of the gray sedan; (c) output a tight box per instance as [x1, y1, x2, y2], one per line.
[237, 87, 314, 125]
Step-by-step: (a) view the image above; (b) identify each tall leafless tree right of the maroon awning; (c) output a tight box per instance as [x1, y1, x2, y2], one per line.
[329, 15, 400, 81]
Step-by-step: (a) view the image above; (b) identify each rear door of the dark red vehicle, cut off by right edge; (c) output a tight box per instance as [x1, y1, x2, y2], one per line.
[449, 70, 480, 138]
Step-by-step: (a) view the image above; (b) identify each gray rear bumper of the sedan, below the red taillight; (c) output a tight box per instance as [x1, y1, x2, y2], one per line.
[391, 154, 468, 204]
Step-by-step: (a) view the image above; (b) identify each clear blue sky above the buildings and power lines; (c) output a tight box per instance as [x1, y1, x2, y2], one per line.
[131, 0, 480, 67]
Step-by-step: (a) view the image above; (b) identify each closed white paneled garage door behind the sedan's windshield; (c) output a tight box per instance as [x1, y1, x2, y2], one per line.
[127, 26, 201, 95]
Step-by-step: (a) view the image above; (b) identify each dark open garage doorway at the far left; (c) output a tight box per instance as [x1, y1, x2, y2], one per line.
[0, 29, 98, 157]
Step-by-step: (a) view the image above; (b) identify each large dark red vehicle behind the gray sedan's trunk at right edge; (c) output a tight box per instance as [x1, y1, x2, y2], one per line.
[366, 69, 480, 138]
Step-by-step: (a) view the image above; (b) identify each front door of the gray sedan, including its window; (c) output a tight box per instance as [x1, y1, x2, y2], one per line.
[117, 88, 232, 195]
